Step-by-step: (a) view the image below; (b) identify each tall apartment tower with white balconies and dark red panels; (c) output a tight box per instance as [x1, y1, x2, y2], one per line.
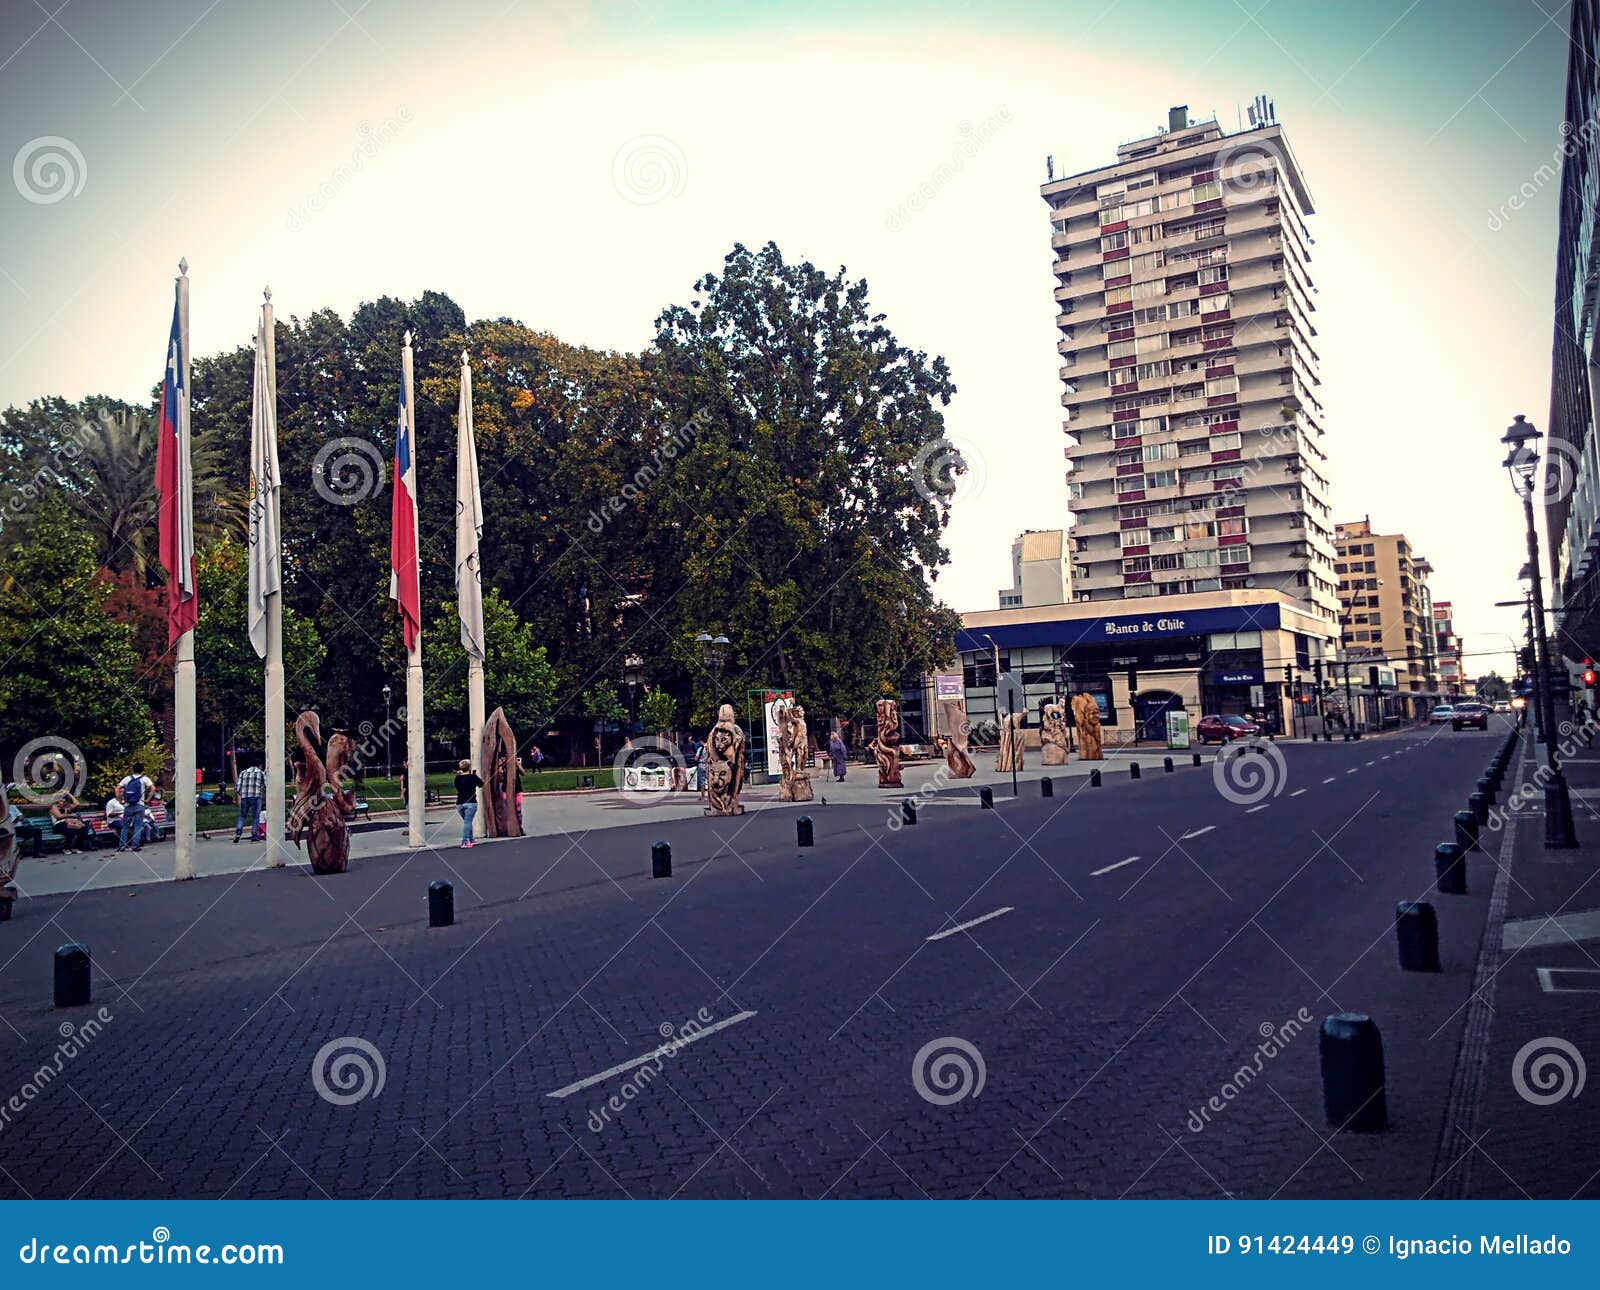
[1042, 99, 1339, 624]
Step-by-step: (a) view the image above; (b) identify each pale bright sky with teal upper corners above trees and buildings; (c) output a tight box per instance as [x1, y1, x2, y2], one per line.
[0, 0, 1568, 674]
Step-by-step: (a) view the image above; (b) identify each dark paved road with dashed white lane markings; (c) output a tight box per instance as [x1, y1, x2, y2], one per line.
[0, 730, 1502, 1197]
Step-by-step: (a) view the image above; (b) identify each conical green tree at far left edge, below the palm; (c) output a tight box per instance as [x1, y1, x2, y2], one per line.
[0, 498, 155, 778]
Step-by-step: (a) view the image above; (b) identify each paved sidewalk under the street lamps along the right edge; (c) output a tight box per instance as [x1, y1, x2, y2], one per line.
[1430, 727, 1600, 1200]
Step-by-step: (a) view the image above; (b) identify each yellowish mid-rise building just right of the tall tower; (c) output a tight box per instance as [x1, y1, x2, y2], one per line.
[1333, 517, 1438, 717]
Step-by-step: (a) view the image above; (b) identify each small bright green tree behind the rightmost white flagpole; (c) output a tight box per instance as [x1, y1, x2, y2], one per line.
[424, 589, 557, 746]
